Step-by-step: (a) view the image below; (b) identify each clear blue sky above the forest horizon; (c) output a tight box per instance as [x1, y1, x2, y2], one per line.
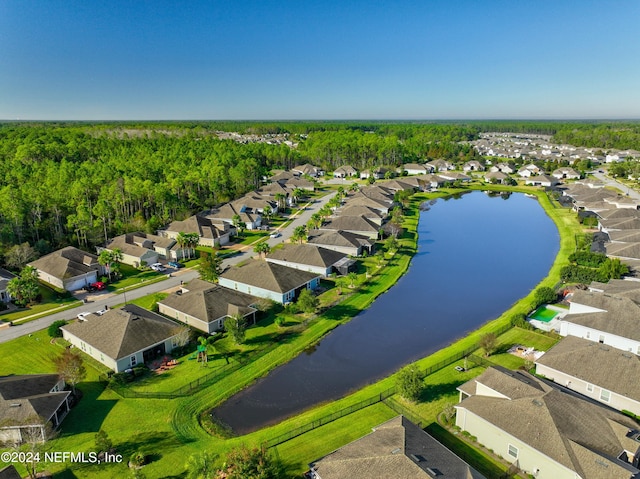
[0, 0, 640, 120]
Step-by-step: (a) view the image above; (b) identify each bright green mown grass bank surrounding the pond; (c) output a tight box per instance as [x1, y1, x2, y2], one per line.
[0, 187, 578, 478]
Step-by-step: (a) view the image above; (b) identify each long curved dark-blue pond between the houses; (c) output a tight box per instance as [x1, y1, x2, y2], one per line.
[212, 192, 560, 434]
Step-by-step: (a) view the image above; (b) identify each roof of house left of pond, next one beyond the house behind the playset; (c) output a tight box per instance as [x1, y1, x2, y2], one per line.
[221, 260, 319, 293]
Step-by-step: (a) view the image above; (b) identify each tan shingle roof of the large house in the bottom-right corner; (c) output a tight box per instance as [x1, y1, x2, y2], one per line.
[457, 368, 638, 479]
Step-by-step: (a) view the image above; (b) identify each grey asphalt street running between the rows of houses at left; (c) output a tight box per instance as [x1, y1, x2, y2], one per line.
[0, 189, 335, 343]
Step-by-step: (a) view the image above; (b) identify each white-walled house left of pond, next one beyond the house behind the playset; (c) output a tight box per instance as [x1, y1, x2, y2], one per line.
[218, 260, 320, 304]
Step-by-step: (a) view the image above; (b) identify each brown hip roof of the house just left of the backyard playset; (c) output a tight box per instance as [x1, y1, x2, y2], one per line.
[61, 304, 180, 360]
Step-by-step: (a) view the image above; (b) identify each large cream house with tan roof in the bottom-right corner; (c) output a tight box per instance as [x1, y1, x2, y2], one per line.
[456, 367, 640, 479]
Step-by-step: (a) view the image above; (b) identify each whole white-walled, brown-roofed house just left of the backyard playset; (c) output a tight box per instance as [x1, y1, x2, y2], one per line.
[60, 304, 181, 373]
